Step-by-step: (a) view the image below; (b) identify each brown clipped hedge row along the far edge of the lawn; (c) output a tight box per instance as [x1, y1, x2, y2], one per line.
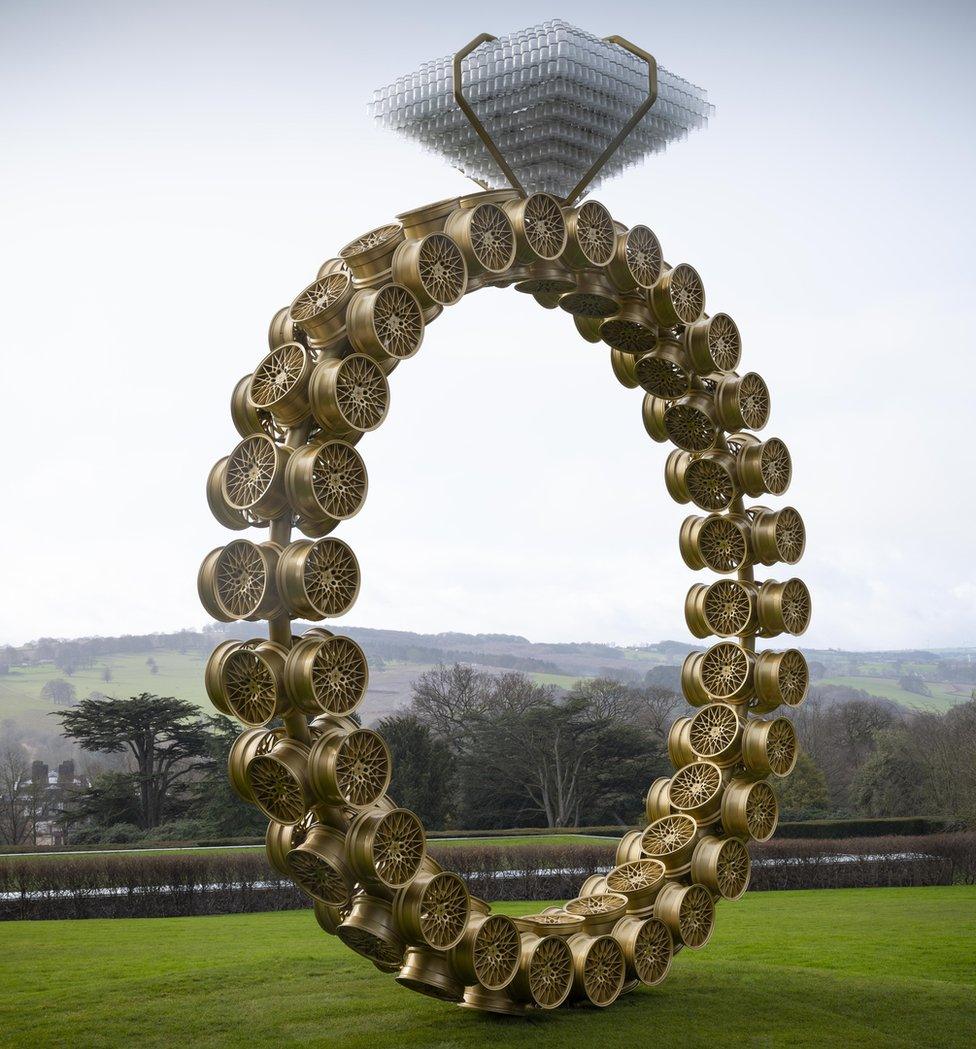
[0, 833, 976, 919]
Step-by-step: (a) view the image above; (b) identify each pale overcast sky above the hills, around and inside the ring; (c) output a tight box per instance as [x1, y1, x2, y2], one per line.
[0, 0, 976, 647]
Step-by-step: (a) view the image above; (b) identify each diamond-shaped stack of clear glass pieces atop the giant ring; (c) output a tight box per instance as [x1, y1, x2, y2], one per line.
[368, 19, 714, 197]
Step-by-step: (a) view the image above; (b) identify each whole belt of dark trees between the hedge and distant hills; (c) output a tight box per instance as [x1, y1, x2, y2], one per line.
[0, 663, 976, 844]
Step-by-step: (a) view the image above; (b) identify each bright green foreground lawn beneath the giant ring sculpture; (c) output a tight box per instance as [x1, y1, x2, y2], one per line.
[0, 886, 976, 1049]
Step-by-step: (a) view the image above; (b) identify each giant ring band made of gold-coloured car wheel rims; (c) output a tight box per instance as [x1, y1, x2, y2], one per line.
[198, 191, 810, 1014]
